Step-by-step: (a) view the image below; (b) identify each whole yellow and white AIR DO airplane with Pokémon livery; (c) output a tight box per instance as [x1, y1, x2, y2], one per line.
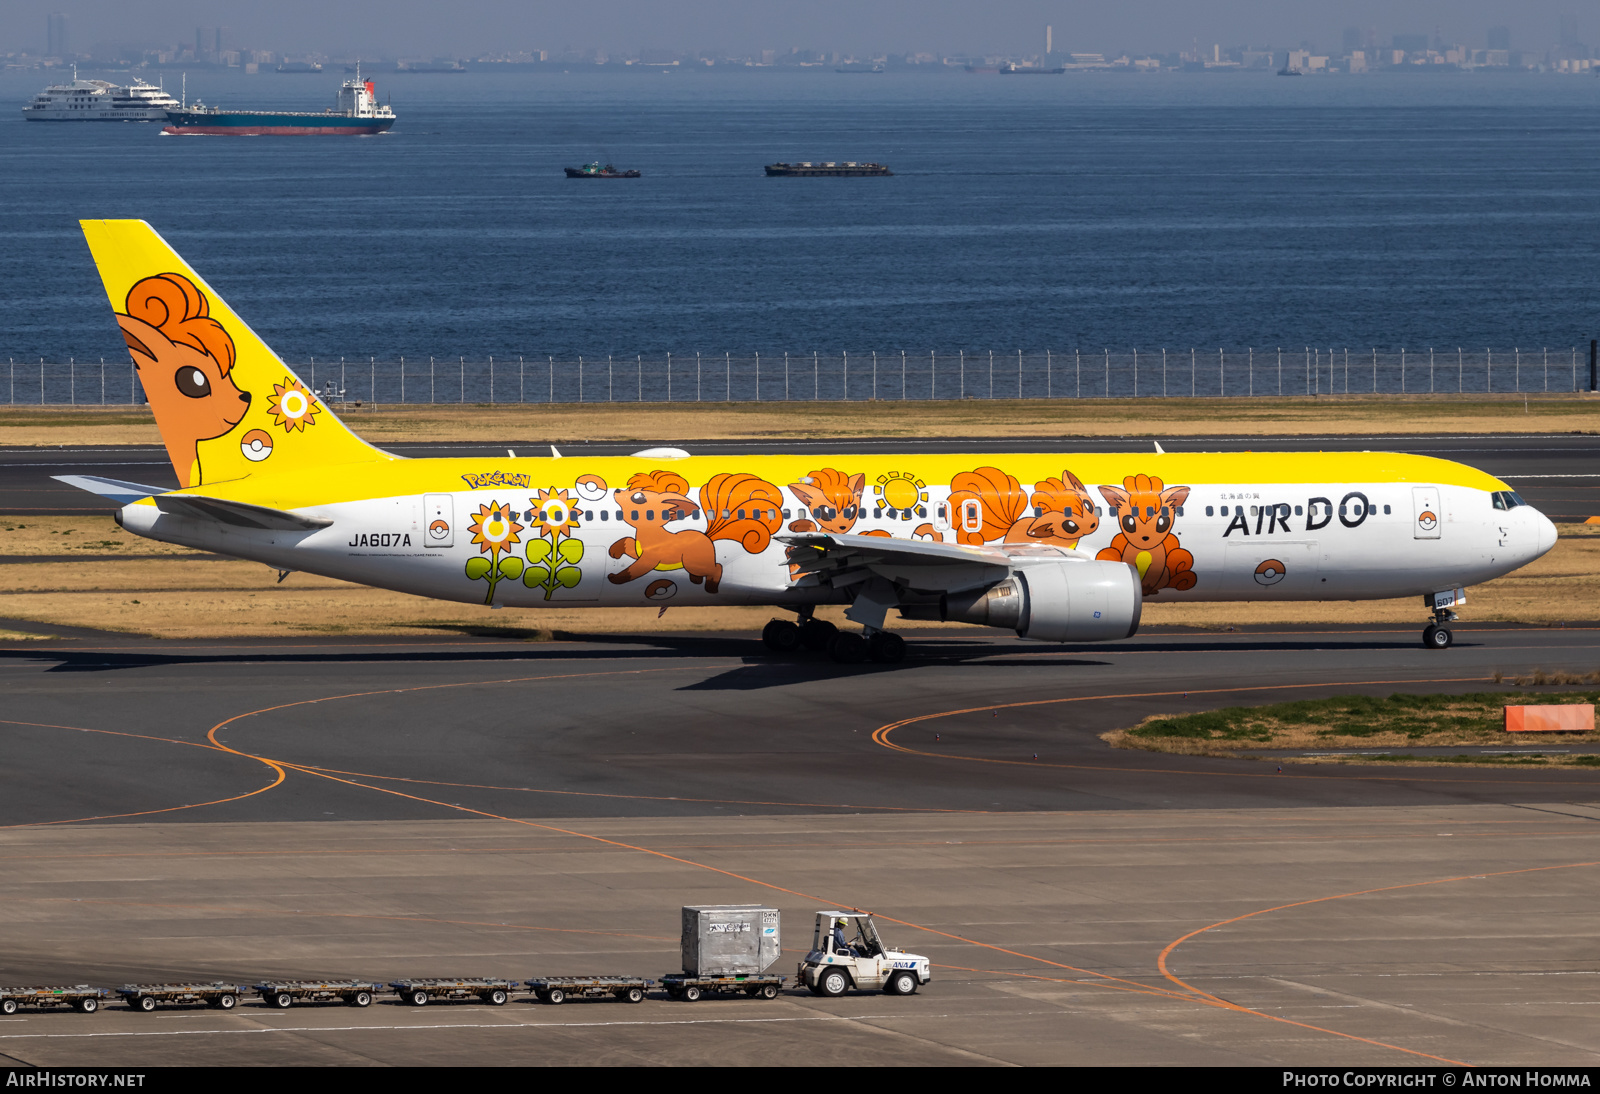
[56, 221, 1557, 664]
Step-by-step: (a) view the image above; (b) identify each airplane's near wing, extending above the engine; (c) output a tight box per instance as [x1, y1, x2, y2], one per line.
[778, 533, 1062, 593]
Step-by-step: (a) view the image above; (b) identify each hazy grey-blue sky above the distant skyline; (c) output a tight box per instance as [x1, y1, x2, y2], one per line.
[0, 0, 1600, 56]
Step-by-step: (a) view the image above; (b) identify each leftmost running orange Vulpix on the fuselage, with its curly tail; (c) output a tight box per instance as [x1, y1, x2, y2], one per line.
[608, 470, 782, 592]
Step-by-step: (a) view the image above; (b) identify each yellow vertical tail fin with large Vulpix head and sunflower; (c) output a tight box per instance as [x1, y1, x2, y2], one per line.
[80, 221, 392, 486]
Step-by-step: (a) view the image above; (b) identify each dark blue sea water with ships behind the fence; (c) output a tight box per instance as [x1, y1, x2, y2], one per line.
[0, 67, 1600, 361]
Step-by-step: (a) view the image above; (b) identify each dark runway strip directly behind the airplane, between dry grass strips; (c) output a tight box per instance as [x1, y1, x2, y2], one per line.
[9, 433, 1600, 521]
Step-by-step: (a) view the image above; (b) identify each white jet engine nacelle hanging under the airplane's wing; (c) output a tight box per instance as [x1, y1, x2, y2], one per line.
[939, 561, 1144, 641]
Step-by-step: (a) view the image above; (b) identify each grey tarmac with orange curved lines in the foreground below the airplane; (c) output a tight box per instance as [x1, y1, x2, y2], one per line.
[0, 627, 1600, 1065]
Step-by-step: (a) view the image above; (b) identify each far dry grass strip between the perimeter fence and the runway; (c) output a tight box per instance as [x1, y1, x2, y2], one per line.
[0, 393, 1600, 446]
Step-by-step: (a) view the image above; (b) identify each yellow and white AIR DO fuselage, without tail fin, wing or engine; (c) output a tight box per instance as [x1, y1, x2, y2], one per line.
[120, 453, 1555, 608]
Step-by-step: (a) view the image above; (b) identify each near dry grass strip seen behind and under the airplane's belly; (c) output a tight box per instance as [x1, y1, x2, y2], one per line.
[0, 515, 1600, 640]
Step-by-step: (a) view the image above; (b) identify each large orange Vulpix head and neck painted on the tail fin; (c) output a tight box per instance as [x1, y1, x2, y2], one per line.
[117, 274, 250, 486]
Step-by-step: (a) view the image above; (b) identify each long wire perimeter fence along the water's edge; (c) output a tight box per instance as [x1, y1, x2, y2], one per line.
[6, 345, 1590, 406]
